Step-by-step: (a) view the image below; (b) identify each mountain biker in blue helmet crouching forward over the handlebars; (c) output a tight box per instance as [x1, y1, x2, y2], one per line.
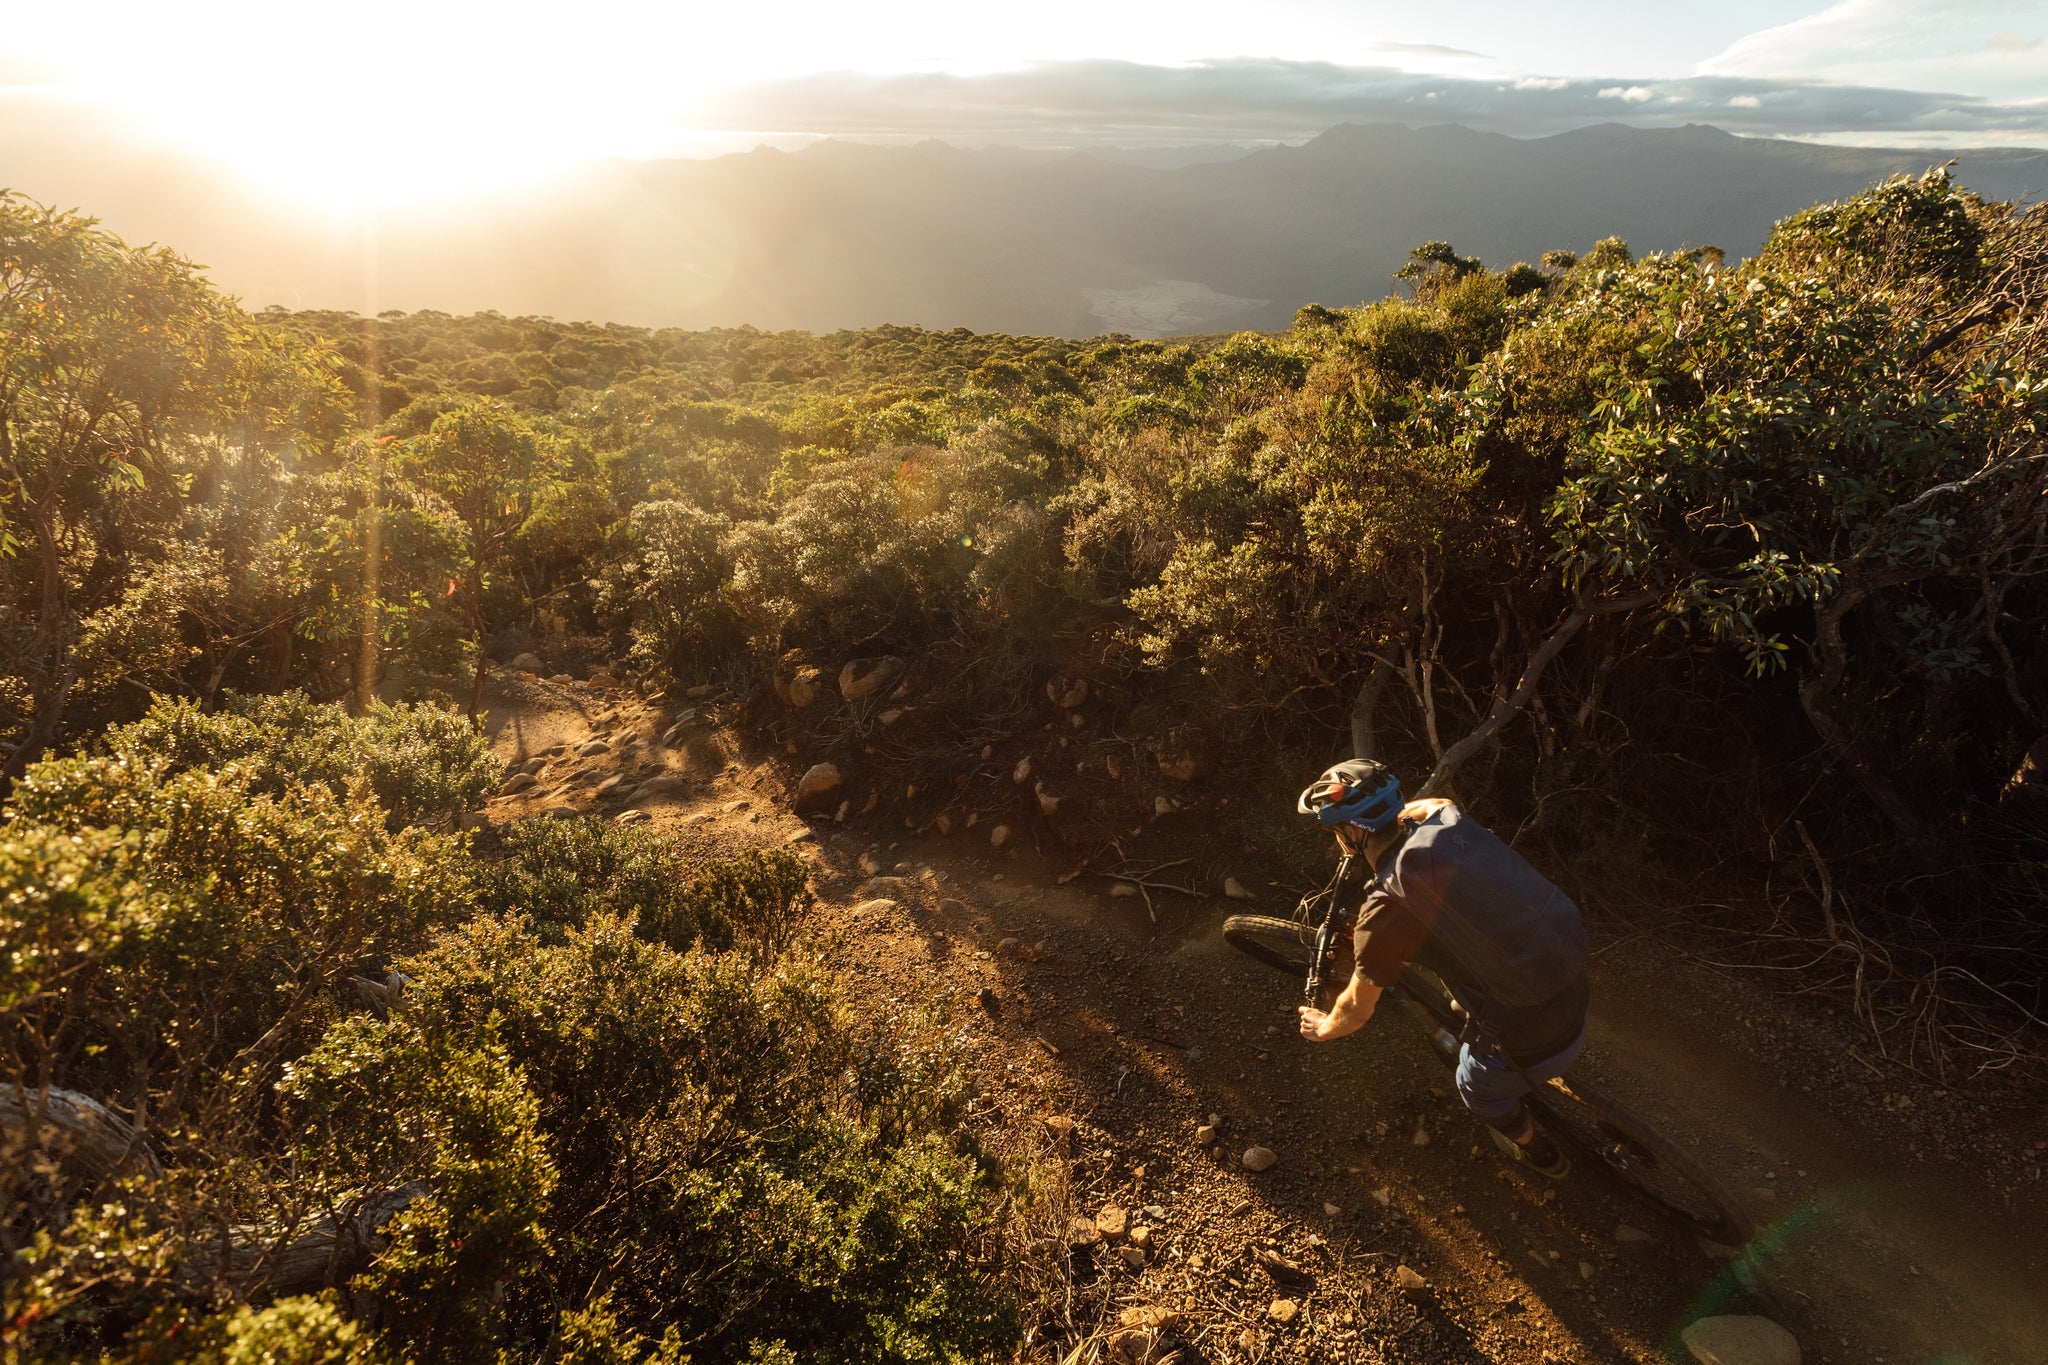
[1296, 759, 1587, 1179]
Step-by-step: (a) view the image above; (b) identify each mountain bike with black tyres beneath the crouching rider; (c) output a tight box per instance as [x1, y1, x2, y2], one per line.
[1223, 855, 1751, 1244]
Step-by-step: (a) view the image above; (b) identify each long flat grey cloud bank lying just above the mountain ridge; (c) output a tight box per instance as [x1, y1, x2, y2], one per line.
[692, 57, 2048, 147]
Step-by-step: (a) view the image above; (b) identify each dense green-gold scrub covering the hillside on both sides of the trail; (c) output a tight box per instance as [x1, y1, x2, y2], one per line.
[0, 174, 2048, 1361]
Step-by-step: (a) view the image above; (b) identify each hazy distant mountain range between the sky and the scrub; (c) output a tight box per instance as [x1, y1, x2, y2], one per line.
[0, 123, 2048, 336]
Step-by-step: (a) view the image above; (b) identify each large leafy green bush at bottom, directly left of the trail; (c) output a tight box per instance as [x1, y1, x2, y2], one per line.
[410, 916, 1018, 1363]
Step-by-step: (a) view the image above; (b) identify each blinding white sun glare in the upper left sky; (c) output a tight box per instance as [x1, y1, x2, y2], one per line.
[12, 0, 753, 211]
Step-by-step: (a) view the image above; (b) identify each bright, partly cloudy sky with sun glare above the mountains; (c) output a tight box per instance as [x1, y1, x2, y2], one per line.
[0, 0, 2048, 203]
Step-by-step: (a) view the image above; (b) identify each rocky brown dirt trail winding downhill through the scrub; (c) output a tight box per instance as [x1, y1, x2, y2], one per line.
[475, 681, 2048, 1365]
